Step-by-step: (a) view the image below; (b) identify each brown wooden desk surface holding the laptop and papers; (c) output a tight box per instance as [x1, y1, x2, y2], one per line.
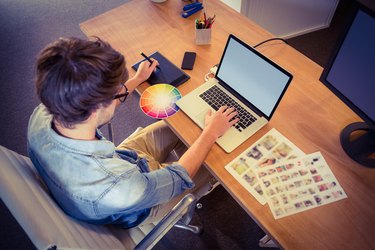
[80, 0, 375, 249]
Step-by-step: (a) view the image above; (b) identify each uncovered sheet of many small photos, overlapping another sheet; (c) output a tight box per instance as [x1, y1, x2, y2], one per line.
[256, 152, 347, 219]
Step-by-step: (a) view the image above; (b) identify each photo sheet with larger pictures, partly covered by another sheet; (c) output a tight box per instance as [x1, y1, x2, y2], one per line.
[225, 128, 304, 205]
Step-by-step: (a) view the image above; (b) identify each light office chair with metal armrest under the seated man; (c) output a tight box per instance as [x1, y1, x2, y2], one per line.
[0, 146, 201, 249]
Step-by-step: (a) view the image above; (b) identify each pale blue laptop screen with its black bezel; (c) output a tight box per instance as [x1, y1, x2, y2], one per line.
[216, 35, 292, 119]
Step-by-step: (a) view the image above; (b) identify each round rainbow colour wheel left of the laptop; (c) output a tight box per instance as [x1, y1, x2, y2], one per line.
[139, 84, 181, 119]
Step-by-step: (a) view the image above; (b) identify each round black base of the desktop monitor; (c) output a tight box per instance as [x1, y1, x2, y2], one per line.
[340, 122, 375, 168]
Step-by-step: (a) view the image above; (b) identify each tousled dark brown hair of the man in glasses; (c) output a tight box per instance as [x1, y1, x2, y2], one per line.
[36, 38, 128, 128]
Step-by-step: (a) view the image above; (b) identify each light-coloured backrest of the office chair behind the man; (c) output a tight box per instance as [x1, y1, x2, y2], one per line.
[0, 146, 126, 249]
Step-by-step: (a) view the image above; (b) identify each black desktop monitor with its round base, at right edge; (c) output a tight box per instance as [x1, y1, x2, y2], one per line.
[320, 2, 375, 167]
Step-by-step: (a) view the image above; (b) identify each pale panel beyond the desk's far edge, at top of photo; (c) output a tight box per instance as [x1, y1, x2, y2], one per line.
[222, 0, 339, 38]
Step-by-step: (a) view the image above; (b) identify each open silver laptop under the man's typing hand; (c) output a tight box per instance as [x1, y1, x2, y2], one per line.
[176, 34, 293, 153]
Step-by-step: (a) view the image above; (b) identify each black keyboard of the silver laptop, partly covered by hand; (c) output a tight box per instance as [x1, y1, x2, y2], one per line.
[199, 86, 256, 132]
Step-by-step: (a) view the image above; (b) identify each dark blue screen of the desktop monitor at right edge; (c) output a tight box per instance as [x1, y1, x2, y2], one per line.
[326, 7, 375, 126]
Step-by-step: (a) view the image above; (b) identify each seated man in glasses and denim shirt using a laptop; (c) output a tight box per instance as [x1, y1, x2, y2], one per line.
[28, 38, 237, 228]
